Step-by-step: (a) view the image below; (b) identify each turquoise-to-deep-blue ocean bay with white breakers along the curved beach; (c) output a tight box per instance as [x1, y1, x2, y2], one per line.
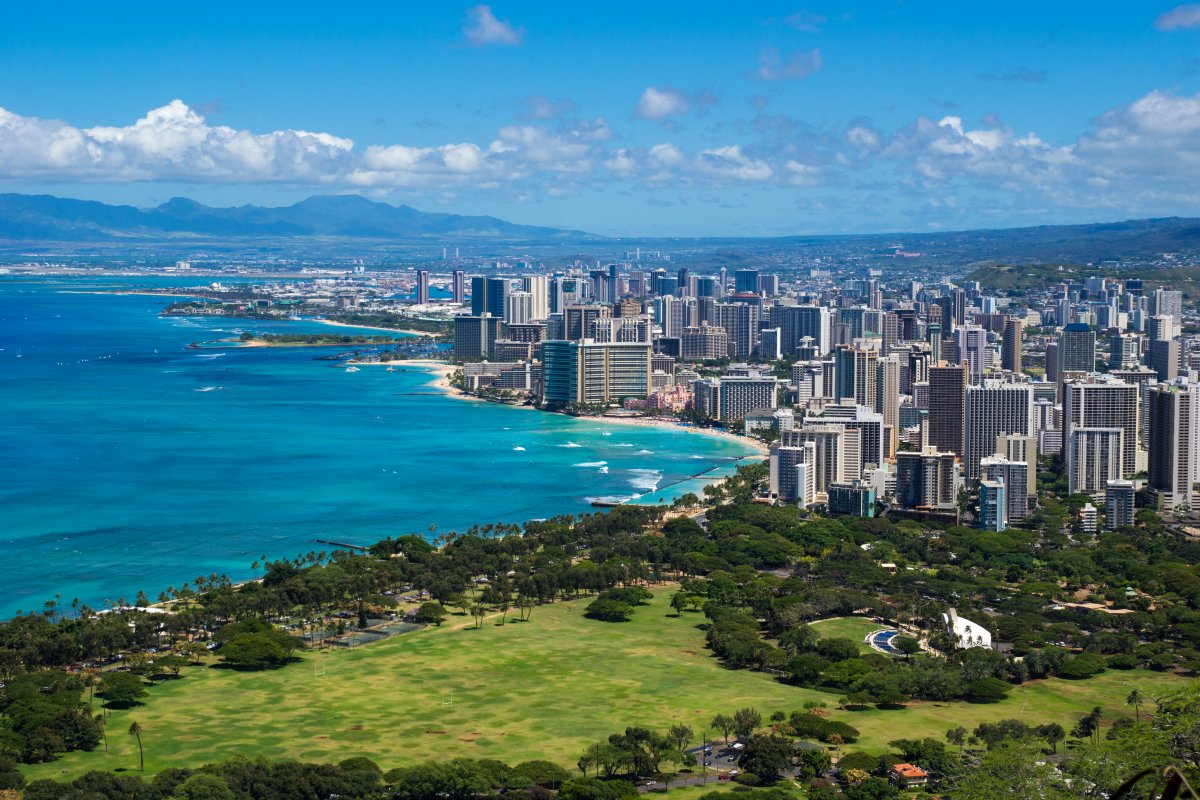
[0, 276, 749, 615]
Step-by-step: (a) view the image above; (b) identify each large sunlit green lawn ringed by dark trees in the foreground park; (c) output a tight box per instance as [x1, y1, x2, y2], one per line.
[18, 590, 1183, 778]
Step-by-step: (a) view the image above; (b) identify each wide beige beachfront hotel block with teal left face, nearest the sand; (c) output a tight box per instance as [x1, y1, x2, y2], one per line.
[541, 339, 650, 409]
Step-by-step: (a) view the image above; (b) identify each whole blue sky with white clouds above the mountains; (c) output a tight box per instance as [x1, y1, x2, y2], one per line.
[0, 1, 1200, 236]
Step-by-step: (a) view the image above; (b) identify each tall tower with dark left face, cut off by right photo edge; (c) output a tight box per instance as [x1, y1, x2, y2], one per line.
[1146, 379, 1200, 509]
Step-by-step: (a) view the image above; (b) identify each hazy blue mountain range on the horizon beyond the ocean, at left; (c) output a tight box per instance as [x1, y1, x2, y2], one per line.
[0, 194, 596, 242]
